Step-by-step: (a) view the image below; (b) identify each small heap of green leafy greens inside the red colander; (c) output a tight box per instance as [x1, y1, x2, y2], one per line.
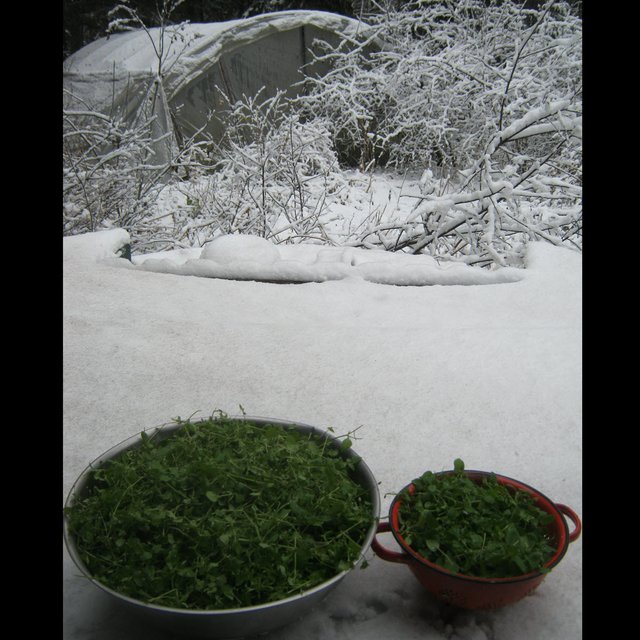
[398, 458, 555, 578]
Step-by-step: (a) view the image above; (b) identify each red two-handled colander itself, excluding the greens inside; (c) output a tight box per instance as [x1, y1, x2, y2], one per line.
[371, 470, 582, 609]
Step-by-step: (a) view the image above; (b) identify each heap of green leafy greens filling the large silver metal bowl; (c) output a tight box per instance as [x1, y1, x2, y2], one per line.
[66, 414, 373, 610]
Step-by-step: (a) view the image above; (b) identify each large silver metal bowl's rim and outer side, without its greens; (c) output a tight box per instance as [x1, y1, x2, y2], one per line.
[64, 416, 380, 639]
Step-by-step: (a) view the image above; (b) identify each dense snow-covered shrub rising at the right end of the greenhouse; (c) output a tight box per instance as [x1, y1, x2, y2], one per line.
[299, 0, 582, 169]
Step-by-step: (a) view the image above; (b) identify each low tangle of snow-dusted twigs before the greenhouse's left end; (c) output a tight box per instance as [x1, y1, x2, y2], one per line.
[62, 86, 218, 251]
